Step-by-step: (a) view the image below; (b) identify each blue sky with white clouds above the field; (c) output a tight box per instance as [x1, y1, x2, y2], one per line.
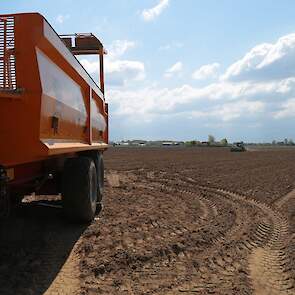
[0, 0, 295, 141]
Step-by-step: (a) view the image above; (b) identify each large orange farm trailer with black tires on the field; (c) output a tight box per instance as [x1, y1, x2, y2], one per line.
[0, 13, 108, 222]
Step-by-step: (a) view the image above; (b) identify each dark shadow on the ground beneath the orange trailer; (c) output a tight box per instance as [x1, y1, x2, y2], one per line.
[0, 201, 87, 295]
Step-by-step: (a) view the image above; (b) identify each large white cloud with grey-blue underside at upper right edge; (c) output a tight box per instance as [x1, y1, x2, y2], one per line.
[222, 34, 295, 82]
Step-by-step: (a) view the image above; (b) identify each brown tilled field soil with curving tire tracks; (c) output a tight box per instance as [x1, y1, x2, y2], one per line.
[0, 147, 295, 295]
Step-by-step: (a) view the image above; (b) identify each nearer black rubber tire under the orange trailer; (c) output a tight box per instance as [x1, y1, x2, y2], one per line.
[62, 157, 98, 223]
